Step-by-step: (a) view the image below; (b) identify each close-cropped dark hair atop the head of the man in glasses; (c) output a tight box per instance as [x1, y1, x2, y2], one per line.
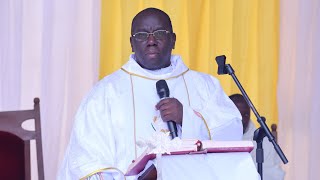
[131, 8, 173, 34]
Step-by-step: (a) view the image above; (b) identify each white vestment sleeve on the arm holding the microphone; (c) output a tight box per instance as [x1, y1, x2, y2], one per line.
[182, 76, 242, 141]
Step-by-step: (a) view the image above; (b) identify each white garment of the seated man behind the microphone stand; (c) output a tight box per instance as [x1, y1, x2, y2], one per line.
[243, 120, 285, 180]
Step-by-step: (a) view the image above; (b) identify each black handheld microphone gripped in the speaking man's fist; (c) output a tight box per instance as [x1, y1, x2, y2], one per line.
[156, 80, 178, 139]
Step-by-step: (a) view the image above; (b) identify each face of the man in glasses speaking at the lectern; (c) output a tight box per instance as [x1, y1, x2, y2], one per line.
[130, 13, 176, 70]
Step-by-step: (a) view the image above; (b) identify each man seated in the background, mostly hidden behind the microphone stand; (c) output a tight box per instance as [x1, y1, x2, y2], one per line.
[230, 94, 284, 180]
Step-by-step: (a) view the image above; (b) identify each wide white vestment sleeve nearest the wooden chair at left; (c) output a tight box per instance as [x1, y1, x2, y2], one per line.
[58, 88, 122, 180]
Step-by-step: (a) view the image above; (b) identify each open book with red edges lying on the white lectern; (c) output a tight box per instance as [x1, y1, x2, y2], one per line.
[125, 139, 253, 176]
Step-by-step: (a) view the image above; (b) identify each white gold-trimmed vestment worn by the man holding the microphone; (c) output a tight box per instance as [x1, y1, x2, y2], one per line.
[58, 55, 242, 180]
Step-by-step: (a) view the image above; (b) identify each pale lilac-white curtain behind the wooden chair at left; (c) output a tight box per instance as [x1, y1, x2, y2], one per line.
[0, 0, 101, 180]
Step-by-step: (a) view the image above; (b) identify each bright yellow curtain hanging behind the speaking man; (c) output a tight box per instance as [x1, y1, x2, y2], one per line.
[100, 0, 279, 129]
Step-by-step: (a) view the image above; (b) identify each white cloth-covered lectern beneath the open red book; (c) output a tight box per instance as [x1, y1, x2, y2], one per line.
[134, 152, 260, 180]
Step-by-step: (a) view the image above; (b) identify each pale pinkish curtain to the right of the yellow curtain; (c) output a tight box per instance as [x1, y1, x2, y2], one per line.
[278, 0, 320, 180]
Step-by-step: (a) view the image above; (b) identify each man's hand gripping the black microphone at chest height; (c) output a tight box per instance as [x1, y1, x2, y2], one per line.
[156, 98, 183, 124]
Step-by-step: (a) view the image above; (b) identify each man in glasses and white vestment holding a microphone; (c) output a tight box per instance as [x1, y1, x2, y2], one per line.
[58, 8, 242, 180]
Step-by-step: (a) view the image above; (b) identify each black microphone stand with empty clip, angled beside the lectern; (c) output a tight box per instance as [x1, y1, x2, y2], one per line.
[216, 55, 288, 180]
